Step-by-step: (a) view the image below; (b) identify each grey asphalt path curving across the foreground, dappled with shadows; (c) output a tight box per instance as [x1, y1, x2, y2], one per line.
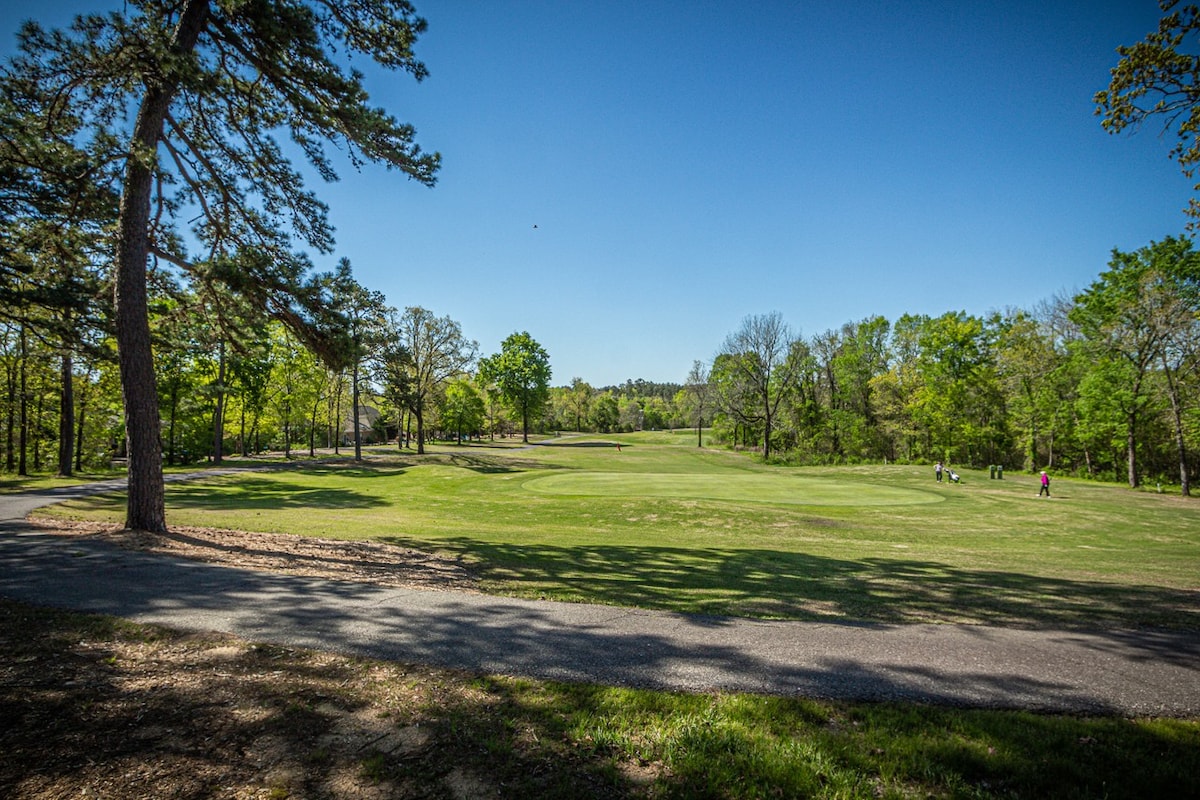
[0, 471, 1200, 717]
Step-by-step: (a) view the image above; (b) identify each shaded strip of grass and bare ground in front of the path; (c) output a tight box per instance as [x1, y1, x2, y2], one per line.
[0, 601, 1200, 800]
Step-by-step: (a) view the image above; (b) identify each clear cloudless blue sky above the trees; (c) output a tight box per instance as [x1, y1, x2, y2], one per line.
[2, 0, 1190, 386]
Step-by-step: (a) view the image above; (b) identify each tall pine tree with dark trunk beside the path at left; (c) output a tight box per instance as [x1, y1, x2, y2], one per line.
[4, 0, 439, 530]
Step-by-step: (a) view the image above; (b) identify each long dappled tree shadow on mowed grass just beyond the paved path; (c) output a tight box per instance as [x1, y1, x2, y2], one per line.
[388, 537, 1200, 631]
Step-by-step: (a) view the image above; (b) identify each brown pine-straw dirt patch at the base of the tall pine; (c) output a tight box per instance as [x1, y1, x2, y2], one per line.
[29, 517, 479, 593]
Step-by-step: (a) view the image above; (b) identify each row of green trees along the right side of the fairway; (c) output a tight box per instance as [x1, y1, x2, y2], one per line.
[694, 237, 1200, 494]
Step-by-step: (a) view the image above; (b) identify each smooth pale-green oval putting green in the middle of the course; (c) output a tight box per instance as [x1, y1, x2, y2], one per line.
[524, 473, 942, 506]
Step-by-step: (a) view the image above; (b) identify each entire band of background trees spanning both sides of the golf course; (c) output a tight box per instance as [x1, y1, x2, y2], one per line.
[9, 232, 1200, 493]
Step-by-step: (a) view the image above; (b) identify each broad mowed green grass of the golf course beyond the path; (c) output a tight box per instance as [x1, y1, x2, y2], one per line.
[44, 433, 1200, 630]
